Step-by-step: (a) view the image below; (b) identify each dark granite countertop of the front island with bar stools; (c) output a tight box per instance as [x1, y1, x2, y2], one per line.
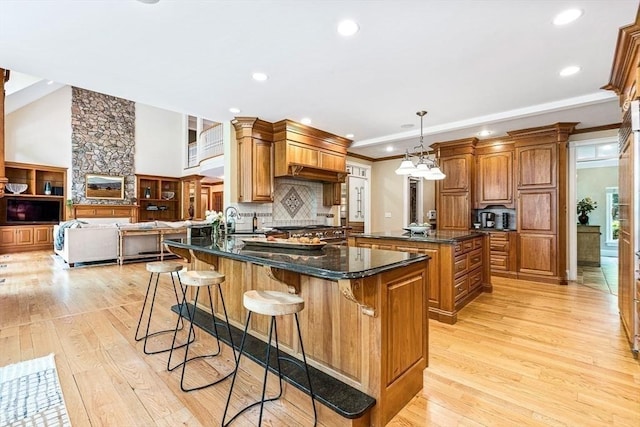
[164, 237, 429, 280]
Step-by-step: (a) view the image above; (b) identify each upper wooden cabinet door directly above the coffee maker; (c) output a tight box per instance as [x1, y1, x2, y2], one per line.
[476, 152, 514, 208]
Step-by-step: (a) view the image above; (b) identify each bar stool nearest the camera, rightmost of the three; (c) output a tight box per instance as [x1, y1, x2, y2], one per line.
[222, 290, 318, 427]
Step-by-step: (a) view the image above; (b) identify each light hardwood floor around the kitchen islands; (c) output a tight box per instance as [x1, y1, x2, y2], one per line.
[0, 252, 640, 427]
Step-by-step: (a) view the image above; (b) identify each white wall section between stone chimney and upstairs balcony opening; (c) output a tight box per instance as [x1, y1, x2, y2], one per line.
[135, 103, 186, 176]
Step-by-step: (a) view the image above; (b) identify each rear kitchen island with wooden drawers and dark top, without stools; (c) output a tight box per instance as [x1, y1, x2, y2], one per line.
[349, 230, 492, 324]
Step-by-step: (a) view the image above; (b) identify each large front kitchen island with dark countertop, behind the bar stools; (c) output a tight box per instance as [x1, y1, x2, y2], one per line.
[165, 237, 429, 426]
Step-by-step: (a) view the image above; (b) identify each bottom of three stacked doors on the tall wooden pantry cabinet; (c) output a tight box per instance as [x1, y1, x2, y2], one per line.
[517, 233, 557, 276]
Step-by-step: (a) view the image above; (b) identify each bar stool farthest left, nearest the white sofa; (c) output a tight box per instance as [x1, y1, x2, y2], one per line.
[135, 261, 183, 354]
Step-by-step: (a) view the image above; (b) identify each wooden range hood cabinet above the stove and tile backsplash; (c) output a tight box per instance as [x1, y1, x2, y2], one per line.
[273, 120, 351, 183]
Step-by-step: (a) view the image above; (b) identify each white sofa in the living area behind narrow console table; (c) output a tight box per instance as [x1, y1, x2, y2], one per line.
[53, 218, 186, 267]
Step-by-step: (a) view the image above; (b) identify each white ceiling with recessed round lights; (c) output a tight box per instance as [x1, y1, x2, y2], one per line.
[0, 0, 638, 158]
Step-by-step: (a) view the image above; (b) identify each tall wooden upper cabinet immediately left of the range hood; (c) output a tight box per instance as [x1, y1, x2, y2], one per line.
[232, 117, 274, 203]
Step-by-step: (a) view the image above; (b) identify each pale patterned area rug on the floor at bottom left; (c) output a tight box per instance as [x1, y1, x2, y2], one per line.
[0, 354, 71, 427]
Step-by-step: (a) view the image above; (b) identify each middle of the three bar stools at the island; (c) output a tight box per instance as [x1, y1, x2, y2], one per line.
[167, 270, 237, 392]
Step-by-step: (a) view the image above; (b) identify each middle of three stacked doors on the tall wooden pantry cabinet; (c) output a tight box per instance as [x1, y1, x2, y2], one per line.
[518, 190, 557, 234]
